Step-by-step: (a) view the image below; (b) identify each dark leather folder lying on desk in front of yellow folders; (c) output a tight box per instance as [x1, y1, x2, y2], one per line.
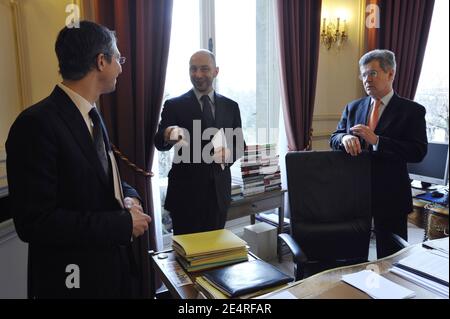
[203, 260, 294, 298]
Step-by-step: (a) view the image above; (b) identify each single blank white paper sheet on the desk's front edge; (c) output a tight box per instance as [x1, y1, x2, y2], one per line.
[342, 270, 416, 299]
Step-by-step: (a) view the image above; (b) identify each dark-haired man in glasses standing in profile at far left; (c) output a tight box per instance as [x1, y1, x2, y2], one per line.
[6, 21, 150, 298]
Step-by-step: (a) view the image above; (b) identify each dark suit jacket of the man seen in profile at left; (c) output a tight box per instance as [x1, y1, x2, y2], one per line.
[6, 87, 137, 298]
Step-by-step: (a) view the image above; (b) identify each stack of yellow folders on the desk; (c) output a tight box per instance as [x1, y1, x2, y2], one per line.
[172, 229, 248, 272]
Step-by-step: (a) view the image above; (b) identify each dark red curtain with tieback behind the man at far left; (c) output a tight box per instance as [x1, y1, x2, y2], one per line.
[94, 0, 173, 297]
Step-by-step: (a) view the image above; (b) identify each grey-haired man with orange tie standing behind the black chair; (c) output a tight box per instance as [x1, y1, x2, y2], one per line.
[330, 50, 427, 258]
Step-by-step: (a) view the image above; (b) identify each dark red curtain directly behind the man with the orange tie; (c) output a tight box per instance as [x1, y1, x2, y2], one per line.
[366, 0, 434, 99]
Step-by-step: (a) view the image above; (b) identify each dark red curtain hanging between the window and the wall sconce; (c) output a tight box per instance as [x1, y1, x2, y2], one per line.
[277, 0, 322, 151]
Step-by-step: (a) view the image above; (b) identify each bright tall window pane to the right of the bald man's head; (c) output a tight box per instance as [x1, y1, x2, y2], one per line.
[215, 0, 279, 144]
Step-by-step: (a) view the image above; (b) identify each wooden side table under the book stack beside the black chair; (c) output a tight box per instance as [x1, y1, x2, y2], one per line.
[227, 189, 286, 260]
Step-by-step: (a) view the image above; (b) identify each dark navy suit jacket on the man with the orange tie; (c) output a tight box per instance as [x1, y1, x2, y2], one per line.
[330, 94, 428, 218]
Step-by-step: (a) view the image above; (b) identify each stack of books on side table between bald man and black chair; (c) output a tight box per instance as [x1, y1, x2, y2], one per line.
[233, 144, 281, 196]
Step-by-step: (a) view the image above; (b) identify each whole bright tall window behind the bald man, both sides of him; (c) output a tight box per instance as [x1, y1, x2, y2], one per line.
[153, 0, 280, 238]
